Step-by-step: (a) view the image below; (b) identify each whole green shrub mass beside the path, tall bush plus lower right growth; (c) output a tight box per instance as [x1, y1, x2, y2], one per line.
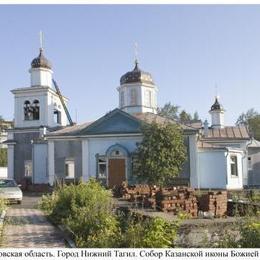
[40, 180, 183, 248]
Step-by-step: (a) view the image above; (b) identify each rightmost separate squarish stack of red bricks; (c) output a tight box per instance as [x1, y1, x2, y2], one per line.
[198, 191, 227, 217]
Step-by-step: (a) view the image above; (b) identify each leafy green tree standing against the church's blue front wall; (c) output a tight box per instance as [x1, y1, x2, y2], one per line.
[134, 122, 186, 186]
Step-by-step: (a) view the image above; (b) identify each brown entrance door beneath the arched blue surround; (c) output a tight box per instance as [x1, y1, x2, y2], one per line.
[108, 159, 126, 188]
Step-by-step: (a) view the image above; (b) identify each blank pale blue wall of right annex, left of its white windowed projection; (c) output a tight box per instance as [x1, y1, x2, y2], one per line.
[198, 149, 227, 189]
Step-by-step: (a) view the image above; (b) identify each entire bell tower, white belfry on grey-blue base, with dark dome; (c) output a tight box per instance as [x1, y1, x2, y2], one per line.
[7, 36, 68, 183]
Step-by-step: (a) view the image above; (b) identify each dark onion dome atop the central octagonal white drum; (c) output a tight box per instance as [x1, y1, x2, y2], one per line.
[120, 60, 154, 85]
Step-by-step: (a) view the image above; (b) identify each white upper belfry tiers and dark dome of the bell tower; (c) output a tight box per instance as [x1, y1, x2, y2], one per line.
[11, 47, 68, 128]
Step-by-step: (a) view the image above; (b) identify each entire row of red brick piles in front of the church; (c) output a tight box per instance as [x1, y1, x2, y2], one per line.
[117, 184, 227, 217]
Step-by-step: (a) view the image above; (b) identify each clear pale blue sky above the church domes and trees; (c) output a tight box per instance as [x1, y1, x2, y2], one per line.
[0, 5, 260, 125]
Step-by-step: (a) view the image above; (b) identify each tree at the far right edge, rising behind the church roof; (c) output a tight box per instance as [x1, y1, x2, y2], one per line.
[236, 108, 260, 140]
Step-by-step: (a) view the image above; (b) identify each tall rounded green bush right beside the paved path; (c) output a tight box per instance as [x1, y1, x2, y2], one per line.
[40, 180, 119, 247]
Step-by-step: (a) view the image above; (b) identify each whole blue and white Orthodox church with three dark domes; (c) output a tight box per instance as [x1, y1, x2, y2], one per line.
[5, 48, 260, 189]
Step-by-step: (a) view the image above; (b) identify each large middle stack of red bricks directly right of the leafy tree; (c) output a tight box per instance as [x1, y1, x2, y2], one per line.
[156, 187, 198, 217]
